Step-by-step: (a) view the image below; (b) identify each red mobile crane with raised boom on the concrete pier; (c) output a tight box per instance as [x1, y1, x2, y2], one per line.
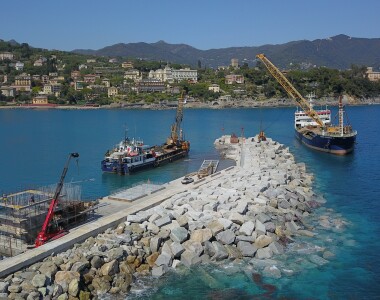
[34, 153, 79, 248]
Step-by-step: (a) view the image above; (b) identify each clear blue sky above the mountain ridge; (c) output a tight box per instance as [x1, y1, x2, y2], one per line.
[0, 0, 380, 51]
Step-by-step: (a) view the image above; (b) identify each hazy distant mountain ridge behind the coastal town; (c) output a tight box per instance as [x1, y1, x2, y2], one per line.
[73, 34, 380, 69]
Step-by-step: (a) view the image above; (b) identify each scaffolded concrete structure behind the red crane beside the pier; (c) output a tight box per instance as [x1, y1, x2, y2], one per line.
[0, 183, 96, 257]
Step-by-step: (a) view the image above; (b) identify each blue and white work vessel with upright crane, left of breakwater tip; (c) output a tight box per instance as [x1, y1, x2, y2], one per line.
[101, 94, 190, 175]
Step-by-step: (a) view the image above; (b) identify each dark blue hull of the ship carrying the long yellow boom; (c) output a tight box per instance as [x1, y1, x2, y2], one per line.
[295, 130, 356, 155]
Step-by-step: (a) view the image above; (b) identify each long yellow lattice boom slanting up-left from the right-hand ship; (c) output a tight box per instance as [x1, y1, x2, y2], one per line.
[256, 54, 325, 128]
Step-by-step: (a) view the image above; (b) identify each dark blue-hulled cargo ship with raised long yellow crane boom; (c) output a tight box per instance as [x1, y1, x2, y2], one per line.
[256, 54, 357, 155]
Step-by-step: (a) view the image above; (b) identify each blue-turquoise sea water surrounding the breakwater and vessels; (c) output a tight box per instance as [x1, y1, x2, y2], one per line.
[0, 105, 380, 299]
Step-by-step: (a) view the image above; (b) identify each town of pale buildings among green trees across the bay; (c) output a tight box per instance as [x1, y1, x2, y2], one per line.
[0, 42, 380, 109]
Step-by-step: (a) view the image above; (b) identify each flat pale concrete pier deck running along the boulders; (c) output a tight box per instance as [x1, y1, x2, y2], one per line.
[0, 167, 234, 277]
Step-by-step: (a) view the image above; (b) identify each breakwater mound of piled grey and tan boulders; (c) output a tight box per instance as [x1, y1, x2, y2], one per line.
[0, 136, 336, 299]
